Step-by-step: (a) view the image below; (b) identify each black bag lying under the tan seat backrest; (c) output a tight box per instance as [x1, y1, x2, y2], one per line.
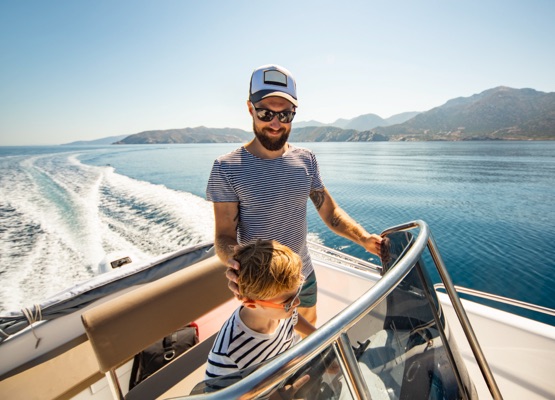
[129, 322, 198, 390]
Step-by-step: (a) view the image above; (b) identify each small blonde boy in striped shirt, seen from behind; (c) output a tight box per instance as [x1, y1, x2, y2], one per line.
[205, 240, 316, 379]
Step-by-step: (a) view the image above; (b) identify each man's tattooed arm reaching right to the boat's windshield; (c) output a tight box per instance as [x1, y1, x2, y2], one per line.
[310, 189, 382, 255]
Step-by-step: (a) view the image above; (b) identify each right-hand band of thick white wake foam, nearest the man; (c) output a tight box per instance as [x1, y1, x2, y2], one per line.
[99, 164, 214, 254]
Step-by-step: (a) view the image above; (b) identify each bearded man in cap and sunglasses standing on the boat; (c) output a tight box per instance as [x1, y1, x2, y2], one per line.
[206, 65, 382, 325]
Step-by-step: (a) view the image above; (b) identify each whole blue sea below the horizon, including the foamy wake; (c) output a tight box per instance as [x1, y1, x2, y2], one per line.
[0, 141, 555, 325]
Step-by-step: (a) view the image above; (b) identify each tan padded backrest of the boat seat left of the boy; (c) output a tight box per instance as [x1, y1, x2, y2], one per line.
[82, 256, 233, 398]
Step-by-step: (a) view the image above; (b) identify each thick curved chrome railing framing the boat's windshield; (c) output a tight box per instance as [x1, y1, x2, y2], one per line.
[186, 221, 502, 399]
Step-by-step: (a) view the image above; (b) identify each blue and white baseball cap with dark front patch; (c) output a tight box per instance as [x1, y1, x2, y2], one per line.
[249, 64, 298, 107]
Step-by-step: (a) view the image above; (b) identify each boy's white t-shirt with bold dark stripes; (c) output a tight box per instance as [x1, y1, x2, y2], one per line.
[205, 306, 300, 379]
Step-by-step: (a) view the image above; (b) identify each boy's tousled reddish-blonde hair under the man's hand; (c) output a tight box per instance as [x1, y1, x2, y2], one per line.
[233, 239, 303, 300]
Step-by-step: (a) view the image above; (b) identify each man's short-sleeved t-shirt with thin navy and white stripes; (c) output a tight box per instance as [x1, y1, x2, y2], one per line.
[206, 145, 324, 277]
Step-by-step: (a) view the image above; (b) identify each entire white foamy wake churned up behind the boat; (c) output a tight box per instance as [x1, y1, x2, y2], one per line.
[0, 153, 214, 311]
